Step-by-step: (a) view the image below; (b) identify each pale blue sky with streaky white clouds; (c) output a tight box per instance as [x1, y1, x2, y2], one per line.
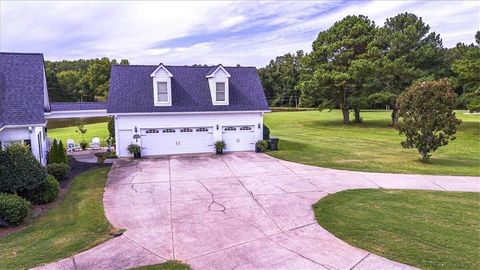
[0, 0, 480, 67]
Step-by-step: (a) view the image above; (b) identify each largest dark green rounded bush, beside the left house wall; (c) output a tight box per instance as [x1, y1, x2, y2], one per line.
[0, 144, 47, 193]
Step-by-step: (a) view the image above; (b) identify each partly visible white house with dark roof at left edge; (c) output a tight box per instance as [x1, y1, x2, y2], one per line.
[0, 52, 50, 165]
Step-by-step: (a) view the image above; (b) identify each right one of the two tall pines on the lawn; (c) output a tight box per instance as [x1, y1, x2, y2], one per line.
[369, 13, 446, 125]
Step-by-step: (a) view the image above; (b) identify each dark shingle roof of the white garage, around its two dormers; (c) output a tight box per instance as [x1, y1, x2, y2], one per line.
[107, 65, 269, 113]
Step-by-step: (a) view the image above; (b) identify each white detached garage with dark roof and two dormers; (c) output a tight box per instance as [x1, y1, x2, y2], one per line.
[107, 64, 269, 157]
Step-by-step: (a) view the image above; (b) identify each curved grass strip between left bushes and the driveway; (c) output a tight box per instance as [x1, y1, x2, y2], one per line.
[0, 168, 113, 269]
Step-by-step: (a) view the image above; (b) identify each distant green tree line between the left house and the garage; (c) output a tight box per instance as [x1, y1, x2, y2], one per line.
[45, 57, 129, 102]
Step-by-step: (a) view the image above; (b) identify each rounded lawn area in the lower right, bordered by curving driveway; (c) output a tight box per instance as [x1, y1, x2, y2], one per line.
[313, 190, 480, 269]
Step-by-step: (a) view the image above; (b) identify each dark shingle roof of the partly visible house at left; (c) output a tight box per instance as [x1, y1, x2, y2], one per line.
[0, 52, 45, 127]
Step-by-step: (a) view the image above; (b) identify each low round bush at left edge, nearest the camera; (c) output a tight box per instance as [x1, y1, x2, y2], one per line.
[0, 193, 30, 226]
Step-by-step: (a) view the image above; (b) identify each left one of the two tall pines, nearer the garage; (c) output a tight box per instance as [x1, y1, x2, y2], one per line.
[298, 15, 376, 124]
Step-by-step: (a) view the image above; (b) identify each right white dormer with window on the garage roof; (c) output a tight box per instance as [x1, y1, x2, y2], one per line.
[206, 64, 231, 105]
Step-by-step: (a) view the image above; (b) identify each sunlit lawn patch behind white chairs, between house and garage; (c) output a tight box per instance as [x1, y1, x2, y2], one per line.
[48, 122, 108, 146]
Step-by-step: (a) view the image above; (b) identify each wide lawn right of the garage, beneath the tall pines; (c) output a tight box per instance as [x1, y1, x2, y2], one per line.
[264, 111, 480, 176]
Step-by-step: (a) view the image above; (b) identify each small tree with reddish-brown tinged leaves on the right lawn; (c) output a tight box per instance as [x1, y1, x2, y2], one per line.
[397, 79, 461, 162]
